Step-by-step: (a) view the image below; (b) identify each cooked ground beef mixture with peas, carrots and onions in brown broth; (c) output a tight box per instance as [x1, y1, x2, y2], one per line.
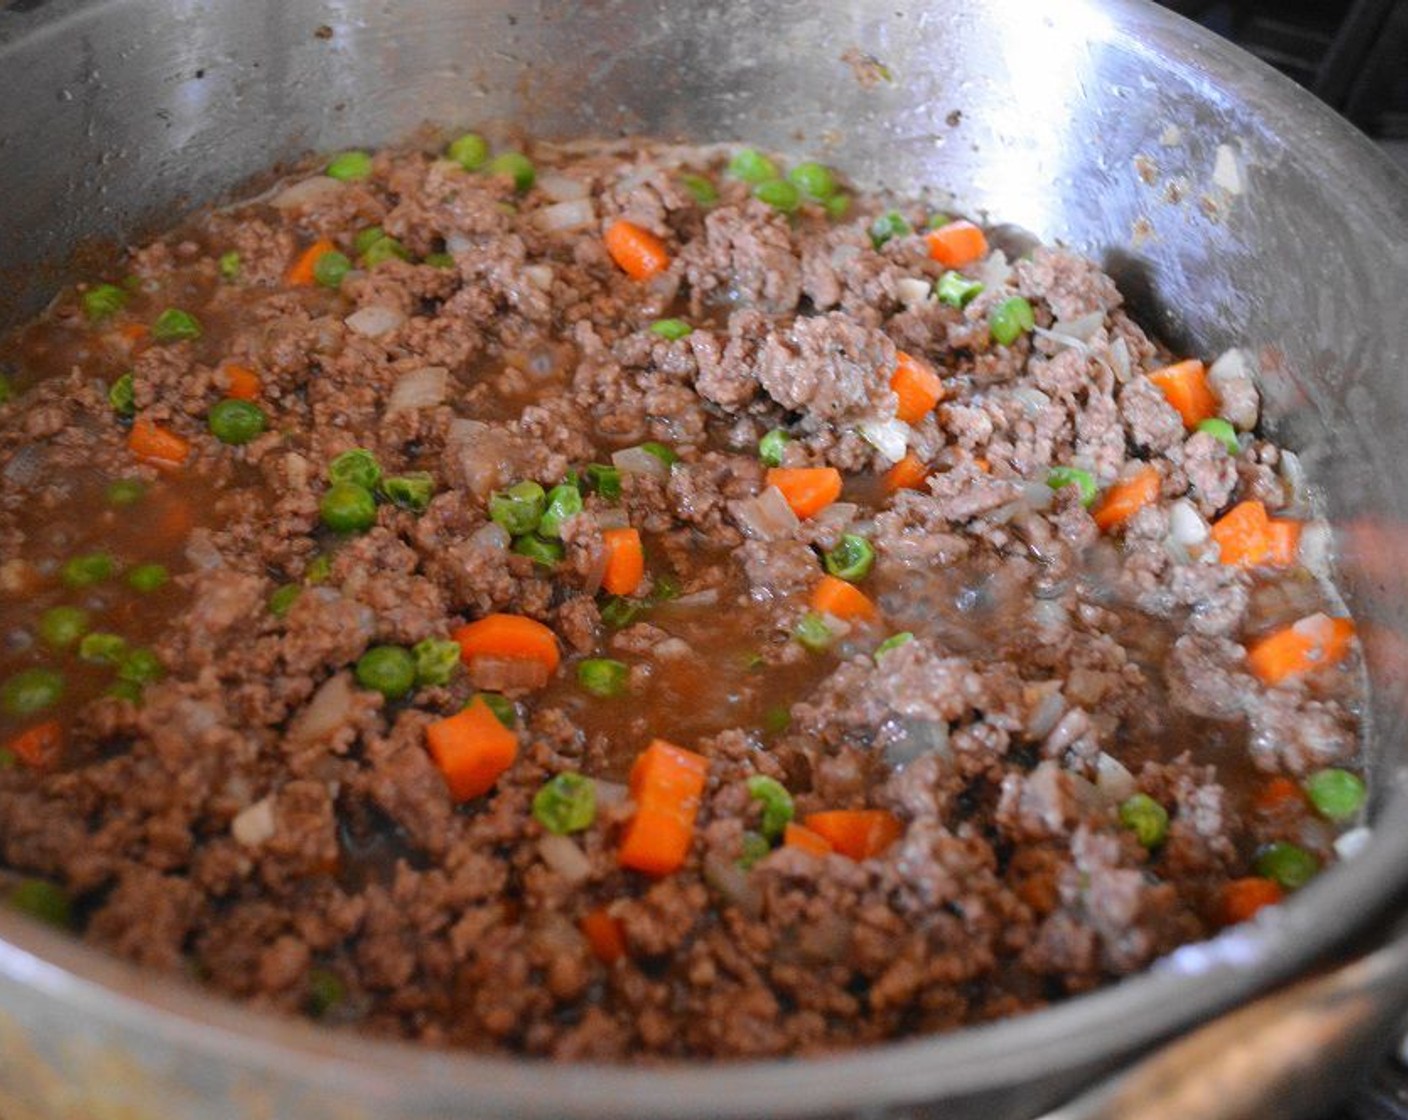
[0, 135, 1364, 1061]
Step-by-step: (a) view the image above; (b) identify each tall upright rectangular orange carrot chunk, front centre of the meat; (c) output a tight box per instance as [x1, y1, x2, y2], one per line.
[617, 740, 708, 875]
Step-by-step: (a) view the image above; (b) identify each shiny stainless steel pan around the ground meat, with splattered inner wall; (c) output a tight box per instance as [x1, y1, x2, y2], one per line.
[0, 0, 1408, 1120]
